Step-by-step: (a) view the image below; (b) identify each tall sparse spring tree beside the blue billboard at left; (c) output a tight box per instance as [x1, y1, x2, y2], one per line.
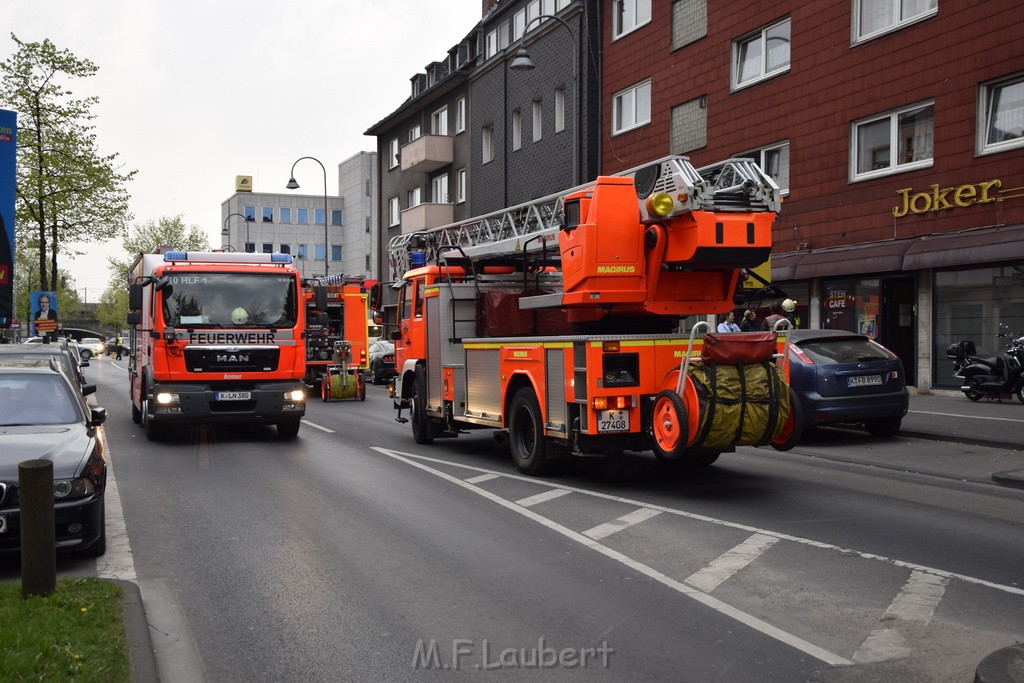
[0, 34, 135, 290]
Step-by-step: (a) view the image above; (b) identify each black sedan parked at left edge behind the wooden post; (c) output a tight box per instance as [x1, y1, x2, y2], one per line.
[0, 356, 106, 556]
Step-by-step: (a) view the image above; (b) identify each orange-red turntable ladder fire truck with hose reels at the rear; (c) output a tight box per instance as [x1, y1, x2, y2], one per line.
[371, 157, 801, 474]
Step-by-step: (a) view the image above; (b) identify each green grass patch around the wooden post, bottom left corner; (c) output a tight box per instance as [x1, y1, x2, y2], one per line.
[0, 579, 131, 683]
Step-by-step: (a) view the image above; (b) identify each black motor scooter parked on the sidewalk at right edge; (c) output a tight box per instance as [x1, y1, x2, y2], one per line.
[946, 324, 1024, 403]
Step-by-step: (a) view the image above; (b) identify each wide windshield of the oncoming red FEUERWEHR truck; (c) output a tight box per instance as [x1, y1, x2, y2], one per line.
[163, 272, 298, 328]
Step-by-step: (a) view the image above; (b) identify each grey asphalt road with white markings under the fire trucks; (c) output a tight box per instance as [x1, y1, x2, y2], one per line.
[0, 358, 1024, 681]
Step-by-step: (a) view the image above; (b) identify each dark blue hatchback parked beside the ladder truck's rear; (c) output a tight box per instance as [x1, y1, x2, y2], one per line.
[788, 330, 909, 436]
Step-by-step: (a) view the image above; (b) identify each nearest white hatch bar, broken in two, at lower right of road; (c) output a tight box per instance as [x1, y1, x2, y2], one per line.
[853, 571, 948, 664]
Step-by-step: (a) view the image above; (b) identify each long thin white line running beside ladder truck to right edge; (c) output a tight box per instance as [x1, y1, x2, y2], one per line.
[373, 454, 1024, 596]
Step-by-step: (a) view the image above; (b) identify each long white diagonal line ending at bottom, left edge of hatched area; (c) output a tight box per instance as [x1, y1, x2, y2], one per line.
[373, 446, 852, 666]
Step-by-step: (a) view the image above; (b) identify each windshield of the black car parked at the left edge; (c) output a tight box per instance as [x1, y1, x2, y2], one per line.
[0, 373, 82, 427]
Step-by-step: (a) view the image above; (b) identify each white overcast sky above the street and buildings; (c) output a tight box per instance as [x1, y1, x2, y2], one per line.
[0, 0, 482, 301]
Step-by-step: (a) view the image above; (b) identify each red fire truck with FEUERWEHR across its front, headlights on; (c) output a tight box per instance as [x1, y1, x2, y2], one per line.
[128, 248, 305, 440]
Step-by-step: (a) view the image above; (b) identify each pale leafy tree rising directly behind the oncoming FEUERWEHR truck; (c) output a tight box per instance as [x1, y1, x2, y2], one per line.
[98, 215, 210, 329]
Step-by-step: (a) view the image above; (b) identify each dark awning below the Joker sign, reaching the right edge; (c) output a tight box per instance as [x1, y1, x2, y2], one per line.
[903, 225, 1024, 270]
